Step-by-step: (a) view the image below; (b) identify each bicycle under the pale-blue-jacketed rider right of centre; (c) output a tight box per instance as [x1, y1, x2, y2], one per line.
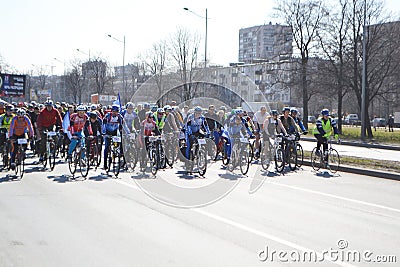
[228, 137, 251, 175]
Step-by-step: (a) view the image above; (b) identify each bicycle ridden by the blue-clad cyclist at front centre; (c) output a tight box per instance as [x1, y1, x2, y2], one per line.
[185, 135, 207, 176]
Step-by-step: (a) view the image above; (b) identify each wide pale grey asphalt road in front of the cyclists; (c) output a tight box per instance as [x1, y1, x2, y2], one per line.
[0, 155, 400, 267]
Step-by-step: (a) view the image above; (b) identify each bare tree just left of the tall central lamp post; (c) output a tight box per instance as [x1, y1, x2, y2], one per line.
[170, 28, 199, 102]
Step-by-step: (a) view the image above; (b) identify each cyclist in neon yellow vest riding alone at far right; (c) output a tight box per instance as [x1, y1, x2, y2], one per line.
[313, 108, 339, 161]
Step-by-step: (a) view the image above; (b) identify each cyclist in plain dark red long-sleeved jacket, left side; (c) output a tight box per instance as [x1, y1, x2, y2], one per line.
[36, 100, 62, 161]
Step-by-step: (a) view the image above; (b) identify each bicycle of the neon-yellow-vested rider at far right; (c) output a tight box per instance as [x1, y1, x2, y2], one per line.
[311, 137, 340, 173]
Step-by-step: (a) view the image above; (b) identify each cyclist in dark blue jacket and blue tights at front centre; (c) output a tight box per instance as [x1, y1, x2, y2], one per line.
[185, 106, 210, 159]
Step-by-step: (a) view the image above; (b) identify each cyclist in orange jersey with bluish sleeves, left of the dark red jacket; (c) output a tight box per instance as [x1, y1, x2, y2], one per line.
[9, 108, 34, 170]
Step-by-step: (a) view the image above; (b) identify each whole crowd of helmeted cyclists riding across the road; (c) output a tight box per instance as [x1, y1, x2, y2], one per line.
[0, 99, 338, 176]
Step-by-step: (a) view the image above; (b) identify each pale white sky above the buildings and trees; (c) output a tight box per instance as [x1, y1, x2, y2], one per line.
[0, 0, 400, 75]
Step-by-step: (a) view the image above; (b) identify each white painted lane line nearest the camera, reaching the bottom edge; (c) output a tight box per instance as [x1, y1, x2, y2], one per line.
[195, 209, 355, 266]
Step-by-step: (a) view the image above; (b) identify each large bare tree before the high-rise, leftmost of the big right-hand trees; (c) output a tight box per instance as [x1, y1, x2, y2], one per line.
[277, 0, 327, 130]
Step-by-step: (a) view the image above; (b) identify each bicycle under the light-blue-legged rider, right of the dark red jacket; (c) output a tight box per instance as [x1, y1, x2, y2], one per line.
[68, 136, 90, 179]
